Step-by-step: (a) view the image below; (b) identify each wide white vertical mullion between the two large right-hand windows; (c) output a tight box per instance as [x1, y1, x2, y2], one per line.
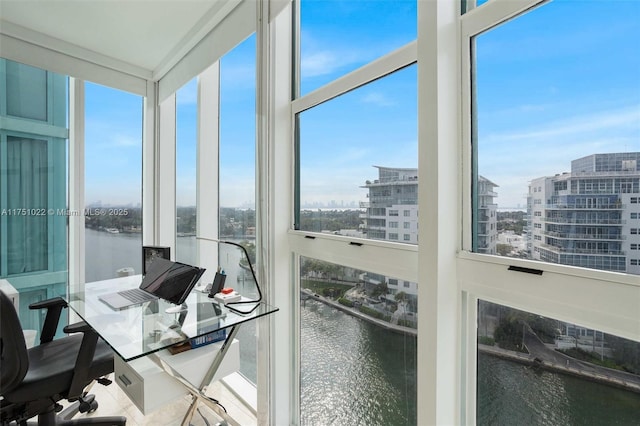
[417, 2, 462, 424]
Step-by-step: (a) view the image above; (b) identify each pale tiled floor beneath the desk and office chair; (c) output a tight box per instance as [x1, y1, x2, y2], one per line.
[74, 376, 257, 426]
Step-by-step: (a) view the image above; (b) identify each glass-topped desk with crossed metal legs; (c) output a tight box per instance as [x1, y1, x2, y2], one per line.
[67, 275, 278, 425]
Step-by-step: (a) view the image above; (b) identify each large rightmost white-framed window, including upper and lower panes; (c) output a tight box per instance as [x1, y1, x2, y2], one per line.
[464, 1, 640, 424]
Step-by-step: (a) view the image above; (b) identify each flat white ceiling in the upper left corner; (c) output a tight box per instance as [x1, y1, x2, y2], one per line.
[0, 0, 232, 76]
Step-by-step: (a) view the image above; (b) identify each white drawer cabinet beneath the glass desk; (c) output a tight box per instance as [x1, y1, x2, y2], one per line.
[114, 339, 240, 414]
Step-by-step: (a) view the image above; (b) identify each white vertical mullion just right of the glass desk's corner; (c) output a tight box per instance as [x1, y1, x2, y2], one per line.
[268, 4, 300, 425]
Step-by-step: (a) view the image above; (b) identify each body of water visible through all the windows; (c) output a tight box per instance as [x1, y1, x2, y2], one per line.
[86, 229, 640, 426]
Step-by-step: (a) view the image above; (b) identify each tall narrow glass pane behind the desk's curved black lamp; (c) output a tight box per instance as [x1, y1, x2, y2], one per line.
[219, 34, 257, 384]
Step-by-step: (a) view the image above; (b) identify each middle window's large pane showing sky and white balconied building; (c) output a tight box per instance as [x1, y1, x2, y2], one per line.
[297, 65, 418, 243]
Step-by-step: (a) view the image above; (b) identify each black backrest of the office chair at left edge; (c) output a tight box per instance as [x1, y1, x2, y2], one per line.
[0, 290, 29, 395]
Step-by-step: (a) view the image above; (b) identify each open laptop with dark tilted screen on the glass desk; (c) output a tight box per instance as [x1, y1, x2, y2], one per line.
[98, 258, 205, 310]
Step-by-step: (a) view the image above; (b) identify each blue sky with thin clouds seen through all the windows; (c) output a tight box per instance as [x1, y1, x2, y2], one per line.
[87, 0, 640, 208]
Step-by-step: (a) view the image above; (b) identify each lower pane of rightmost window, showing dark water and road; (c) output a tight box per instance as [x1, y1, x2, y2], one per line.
[477, 300, 640, 425]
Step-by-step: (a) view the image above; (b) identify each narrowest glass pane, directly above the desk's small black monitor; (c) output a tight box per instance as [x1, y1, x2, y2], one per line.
[175, 78, 198, 265]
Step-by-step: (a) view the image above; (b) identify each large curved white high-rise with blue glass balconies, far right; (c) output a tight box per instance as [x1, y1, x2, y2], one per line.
[527, 152, 640, 274]
